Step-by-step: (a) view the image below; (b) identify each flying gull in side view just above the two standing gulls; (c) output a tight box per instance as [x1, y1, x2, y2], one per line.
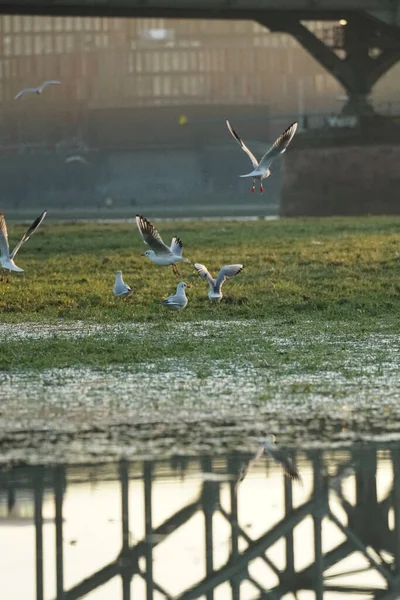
[136, 215, 190, 275]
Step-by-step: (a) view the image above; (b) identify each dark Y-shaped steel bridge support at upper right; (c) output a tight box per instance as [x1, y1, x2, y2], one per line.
[259, 14, 400, 116]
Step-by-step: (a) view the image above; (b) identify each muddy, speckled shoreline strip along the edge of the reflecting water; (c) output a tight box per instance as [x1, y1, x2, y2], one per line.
[0, 409, 400, 467]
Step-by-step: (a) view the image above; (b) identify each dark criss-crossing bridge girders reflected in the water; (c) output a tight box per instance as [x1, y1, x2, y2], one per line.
[0, 447, 400, 600]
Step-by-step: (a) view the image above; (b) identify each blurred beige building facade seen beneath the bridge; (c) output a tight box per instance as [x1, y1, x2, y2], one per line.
[0, 15, 400, 143]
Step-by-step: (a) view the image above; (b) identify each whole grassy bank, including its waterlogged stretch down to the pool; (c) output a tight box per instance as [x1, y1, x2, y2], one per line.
[0, 217, 400, 461]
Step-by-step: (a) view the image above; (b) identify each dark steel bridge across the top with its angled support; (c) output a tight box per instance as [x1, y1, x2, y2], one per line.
[0, 0, 400, 116]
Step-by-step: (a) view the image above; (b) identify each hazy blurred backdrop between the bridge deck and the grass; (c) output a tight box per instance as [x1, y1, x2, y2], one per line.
[0, 15, 400, 218]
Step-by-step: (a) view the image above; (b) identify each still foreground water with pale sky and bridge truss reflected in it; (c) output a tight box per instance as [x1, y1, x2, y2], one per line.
[0, 444, 400, 600]
